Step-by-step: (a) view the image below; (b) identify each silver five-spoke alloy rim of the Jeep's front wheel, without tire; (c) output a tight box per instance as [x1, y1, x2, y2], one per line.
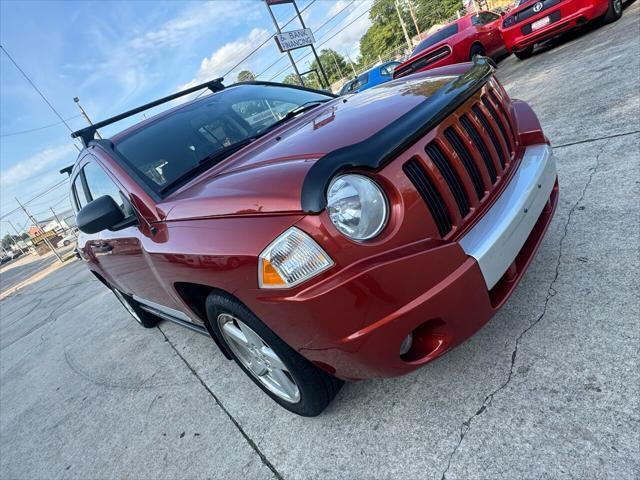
[218, 313, 300, 403]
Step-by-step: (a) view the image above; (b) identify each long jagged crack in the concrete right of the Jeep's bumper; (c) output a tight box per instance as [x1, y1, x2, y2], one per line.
[440, 139, 609, 480]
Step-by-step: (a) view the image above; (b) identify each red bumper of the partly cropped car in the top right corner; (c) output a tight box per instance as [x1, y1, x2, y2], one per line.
[501, 0, 608, 52]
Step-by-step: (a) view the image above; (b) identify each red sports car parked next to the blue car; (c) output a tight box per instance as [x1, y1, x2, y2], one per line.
[393, 11, 506, 78]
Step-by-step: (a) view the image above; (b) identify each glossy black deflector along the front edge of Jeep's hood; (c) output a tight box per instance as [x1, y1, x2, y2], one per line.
[301, 56, 495, 213]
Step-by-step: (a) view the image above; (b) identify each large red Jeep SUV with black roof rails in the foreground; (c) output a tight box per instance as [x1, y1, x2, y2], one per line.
[68, 57, 558, 416]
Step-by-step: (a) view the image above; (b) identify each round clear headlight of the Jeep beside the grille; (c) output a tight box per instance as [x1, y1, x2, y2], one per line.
[327, 174, 388, 240]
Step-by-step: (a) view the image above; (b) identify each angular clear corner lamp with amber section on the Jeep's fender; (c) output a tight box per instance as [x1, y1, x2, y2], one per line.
[258, 227, 333, 288]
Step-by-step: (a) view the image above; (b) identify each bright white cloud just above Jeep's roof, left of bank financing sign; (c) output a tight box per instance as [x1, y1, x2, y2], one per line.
[180, 28, 270, 90]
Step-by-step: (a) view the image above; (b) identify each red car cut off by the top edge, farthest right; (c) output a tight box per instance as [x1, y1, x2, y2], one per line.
[500, 0, 622, 60]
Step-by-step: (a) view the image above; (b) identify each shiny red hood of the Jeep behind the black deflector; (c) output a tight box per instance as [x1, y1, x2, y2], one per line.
[158, 72, 460, 221]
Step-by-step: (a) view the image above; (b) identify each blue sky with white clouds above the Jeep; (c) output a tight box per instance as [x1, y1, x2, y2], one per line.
[0, 0, 371, 236]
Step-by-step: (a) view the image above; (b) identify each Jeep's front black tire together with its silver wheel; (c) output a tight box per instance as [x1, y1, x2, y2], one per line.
[206, 294, 344, 417]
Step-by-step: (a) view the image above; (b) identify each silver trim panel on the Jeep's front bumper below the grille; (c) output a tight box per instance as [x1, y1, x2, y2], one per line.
[459, 145, 557, 290]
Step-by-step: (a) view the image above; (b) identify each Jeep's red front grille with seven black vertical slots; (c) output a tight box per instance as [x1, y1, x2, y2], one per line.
[403, 83, 517, 237]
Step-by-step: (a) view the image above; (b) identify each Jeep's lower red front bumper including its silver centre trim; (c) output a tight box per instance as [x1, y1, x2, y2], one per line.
[280, 145, 558, 380]
